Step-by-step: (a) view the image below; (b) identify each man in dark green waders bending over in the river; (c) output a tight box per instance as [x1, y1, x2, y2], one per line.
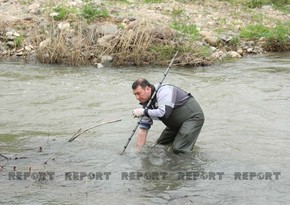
[132, 78, 204, 154]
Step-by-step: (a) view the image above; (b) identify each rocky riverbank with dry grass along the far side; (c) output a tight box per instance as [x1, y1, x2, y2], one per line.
[0, 0, 290, 66]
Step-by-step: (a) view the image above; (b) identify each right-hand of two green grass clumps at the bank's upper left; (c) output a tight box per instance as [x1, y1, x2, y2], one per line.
[81, 3, 109, 21]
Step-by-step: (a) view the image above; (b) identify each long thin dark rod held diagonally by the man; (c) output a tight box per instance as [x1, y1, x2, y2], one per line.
[121, 51, 178, 155]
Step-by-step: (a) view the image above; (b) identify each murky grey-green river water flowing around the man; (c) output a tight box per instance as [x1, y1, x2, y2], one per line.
[0, 53, 290, 205]
